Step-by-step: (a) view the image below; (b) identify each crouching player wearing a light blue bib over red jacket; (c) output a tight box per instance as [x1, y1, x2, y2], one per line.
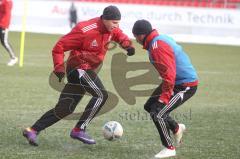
[132, 20, 198, 158]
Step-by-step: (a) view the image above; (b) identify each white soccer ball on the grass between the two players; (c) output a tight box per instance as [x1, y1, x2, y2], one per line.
[102, 121, 123, 141]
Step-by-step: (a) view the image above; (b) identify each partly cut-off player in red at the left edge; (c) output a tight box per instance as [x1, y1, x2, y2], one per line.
[0, 0, 18, 66]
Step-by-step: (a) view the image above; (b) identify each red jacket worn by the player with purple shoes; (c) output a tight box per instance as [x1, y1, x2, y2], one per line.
[52, 17, 131, 72]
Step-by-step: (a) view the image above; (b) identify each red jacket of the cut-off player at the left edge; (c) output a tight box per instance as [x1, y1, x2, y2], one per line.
[0, 0, 12, 29]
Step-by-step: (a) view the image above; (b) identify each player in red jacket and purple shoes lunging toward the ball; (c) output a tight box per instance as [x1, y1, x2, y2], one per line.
[23, 6, 135, 146]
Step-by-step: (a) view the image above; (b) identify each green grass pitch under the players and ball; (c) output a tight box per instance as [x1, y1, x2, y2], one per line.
[0, 32, 240, 159]
